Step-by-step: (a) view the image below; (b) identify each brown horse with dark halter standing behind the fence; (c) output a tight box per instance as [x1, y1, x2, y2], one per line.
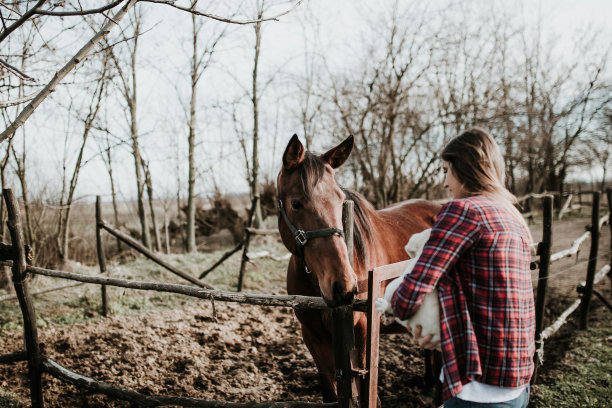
[277, 135, 440, 402]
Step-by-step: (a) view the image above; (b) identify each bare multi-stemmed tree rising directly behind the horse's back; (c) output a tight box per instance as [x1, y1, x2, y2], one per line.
[331, 3, 435, 207]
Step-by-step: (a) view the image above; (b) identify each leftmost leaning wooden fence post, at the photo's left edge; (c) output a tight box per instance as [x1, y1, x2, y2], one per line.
[2, 188, 44, 408]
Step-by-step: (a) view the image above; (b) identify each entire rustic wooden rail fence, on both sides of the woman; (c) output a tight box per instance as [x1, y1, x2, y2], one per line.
[0, 189, 612, 408]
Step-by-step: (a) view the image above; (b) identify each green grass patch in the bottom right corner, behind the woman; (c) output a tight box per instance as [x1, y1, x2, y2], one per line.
[530, 328, 612, 408]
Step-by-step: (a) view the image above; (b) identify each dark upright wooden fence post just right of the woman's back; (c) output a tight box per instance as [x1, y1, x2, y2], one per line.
[531, 195, 553, 384]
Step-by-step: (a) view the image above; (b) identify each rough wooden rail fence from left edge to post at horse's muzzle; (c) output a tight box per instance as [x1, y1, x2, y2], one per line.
[0, 189, 358, 408]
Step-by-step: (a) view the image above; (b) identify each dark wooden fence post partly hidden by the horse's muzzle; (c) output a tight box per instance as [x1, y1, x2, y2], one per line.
[332, 201, 360, 408]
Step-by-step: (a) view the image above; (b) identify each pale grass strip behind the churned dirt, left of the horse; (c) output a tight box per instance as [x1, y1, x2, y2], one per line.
[0, 241, 288, 337]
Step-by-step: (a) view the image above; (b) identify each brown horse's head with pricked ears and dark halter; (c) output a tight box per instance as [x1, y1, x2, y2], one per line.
[277, 135, 357, 306]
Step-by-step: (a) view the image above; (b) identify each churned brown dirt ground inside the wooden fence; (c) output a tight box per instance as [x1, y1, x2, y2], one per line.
[0, 218, 612, 407]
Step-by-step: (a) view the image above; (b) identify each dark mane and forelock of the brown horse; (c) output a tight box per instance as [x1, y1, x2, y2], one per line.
[298, 152, 375, 265]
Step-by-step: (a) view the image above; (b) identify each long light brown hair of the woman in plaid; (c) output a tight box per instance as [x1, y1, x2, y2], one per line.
[441, 127, 532, 240]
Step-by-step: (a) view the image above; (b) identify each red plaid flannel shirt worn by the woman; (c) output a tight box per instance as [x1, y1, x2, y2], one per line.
[391, 196, 535, 400]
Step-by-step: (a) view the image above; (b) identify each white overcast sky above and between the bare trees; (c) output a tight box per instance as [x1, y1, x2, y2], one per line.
[2, 0, 612, 204]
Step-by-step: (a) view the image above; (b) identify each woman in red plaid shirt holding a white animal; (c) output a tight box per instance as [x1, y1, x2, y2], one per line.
[391, 128, 535, 408]
